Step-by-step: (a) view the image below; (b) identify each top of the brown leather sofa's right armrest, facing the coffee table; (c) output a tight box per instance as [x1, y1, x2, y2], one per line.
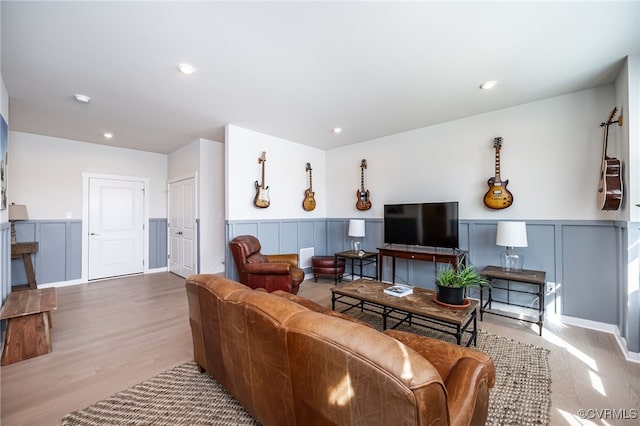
[384, 330, 496, 388]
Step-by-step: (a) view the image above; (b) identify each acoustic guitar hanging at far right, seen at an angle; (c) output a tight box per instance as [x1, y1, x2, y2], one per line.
[598, 108, 622, 210]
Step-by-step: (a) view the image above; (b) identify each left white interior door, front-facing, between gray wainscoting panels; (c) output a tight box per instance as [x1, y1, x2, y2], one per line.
[88, 178, 144, 280]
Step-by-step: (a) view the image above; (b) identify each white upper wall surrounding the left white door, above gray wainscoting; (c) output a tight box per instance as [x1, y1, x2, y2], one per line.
[8, 132, 167, 219]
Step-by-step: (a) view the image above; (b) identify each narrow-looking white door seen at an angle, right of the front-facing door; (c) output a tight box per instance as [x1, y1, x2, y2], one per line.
[169, 178, 197, 278]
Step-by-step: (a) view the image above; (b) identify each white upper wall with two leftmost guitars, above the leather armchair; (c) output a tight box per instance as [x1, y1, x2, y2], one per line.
[225, 125, 324, 220]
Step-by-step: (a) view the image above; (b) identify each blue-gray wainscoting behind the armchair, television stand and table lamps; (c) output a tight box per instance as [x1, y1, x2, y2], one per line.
[226, 218, 626, 332]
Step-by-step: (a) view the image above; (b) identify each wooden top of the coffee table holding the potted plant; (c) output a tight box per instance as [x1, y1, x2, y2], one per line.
[331, 280, 478, 324]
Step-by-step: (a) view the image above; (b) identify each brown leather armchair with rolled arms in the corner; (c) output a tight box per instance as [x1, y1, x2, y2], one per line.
[229, 235, 304, 294]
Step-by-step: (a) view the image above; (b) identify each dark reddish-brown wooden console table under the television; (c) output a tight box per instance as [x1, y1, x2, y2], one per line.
[378, 244, 466, 283]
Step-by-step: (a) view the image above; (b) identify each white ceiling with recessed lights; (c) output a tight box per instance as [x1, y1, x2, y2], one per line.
[1, 0, 640, 153]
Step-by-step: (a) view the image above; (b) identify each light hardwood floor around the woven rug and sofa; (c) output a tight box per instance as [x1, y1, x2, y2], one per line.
[0, 273, 640, 426]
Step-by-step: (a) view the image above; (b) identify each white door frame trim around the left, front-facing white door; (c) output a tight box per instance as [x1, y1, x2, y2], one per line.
[80, 172, 149, 283]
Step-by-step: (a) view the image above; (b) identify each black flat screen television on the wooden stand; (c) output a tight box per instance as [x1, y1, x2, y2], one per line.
[384, 201, 459, 248]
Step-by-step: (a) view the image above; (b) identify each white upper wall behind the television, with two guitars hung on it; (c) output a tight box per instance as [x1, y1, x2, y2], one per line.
[327, 85, 620, 220]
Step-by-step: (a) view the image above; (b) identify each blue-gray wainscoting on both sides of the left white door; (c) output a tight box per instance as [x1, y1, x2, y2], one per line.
[12, 218, 167, 285]
